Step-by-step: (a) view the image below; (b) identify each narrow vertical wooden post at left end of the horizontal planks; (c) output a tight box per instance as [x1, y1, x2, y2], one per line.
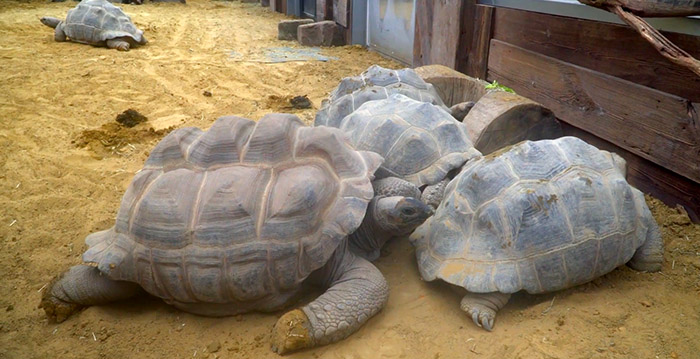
[466, 5, 494, 79]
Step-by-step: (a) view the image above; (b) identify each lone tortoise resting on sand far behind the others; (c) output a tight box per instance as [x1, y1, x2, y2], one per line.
[41, 0, 148, 51]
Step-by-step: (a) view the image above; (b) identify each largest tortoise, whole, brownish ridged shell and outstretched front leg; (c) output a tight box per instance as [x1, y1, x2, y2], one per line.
[40, 114, 432, 353]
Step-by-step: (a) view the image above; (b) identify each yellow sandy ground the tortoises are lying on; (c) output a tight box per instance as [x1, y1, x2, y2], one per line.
[0, 0, 700, 359]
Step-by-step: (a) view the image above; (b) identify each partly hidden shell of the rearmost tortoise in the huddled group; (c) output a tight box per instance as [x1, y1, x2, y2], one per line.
[314, 65, 450, 127]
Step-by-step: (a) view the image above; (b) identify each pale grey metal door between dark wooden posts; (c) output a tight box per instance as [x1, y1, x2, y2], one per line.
[367, 0, 416, 64]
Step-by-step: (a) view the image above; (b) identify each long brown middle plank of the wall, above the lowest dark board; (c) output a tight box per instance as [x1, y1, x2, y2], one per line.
[488, 39, 700, 182]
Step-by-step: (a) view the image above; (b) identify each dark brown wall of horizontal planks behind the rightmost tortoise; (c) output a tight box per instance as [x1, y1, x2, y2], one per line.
[460, 4, 700, 221]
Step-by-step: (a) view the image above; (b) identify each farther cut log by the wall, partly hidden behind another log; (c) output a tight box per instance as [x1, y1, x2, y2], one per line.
[415, 65, 488, 107]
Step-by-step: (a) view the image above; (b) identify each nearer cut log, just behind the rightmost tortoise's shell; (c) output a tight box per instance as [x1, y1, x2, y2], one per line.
[463, 91, 562, 155]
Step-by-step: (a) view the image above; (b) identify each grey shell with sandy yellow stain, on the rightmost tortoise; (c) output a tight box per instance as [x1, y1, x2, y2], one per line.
[411, 137, 653, 293]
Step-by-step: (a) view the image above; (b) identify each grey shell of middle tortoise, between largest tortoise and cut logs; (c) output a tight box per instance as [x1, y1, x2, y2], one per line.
[330, 94, 481, 187]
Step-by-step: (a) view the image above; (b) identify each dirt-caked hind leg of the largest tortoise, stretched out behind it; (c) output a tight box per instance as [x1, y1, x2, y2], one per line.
[39, 265, 140, 323]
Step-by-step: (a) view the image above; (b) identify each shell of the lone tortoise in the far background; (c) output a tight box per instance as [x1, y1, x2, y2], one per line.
[63, 0, 144, 45]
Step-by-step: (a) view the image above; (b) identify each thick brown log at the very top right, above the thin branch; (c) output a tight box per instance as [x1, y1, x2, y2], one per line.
[578, 0, 700, 17]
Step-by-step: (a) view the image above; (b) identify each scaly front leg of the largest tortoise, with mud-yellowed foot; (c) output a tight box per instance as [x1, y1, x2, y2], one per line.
[272, 246, 389, 354]
